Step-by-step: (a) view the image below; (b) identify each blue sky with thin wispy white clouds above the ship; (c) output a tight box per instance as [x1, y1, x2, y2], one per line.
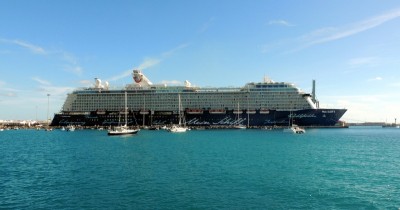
[0, 0, 400, 123]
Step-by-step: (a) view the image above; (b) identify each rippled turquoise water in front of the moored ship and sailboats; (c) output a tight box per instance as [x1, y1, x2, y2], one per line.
[0, 127, 400, 209]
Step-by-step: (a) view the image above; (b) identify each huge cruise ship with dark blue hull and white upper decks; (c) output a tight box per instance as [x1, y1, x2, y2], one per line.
[51, 70, 346, 127]
